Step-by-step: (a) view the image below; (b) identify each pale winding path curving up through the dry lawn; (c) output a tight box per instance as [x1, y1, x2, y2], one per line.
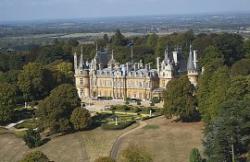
[110, 121, 147, 159]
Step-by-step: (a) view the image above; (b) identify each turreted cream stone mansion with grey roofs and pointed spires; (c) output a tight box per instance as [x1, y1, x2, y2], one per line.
[74, 47, 198, 101]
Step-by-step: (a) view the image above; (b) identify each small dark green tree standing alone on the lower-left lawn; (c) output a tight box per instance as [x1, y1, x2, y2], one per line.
[23, 129, 42, 148]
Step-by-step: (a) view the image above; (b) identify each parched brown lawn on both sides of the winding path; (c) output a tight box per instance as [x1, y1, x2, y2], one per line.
[0, 117, 202, 162]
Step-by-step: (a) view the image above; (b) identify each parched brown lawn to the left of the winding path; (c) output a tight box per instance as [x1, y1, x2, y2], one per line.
[0, 124, 136, 162]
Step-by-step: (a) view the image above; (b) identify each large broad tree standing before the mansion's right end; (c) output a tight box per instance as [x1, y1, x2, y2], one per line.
[164, 76, 198, 121]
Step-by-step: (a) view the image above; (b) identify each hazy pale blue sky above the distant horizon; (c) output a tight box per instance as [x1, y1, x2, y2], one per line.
[0, 0, 250, 21]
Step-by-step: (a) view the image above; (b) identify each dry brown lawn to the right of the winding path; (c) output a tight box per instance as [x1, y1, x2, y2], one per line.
[118, 117, 202, 162]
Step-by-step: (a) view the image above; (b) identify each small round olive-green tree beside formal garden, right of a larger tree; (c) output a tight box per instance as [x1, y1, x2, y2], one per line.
[70, 108, 91, 130]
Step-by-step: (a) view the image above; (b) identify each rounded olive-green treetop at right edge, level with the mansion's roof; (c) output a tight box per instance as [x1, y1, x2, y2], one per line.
[231, 59, 250, 76]
